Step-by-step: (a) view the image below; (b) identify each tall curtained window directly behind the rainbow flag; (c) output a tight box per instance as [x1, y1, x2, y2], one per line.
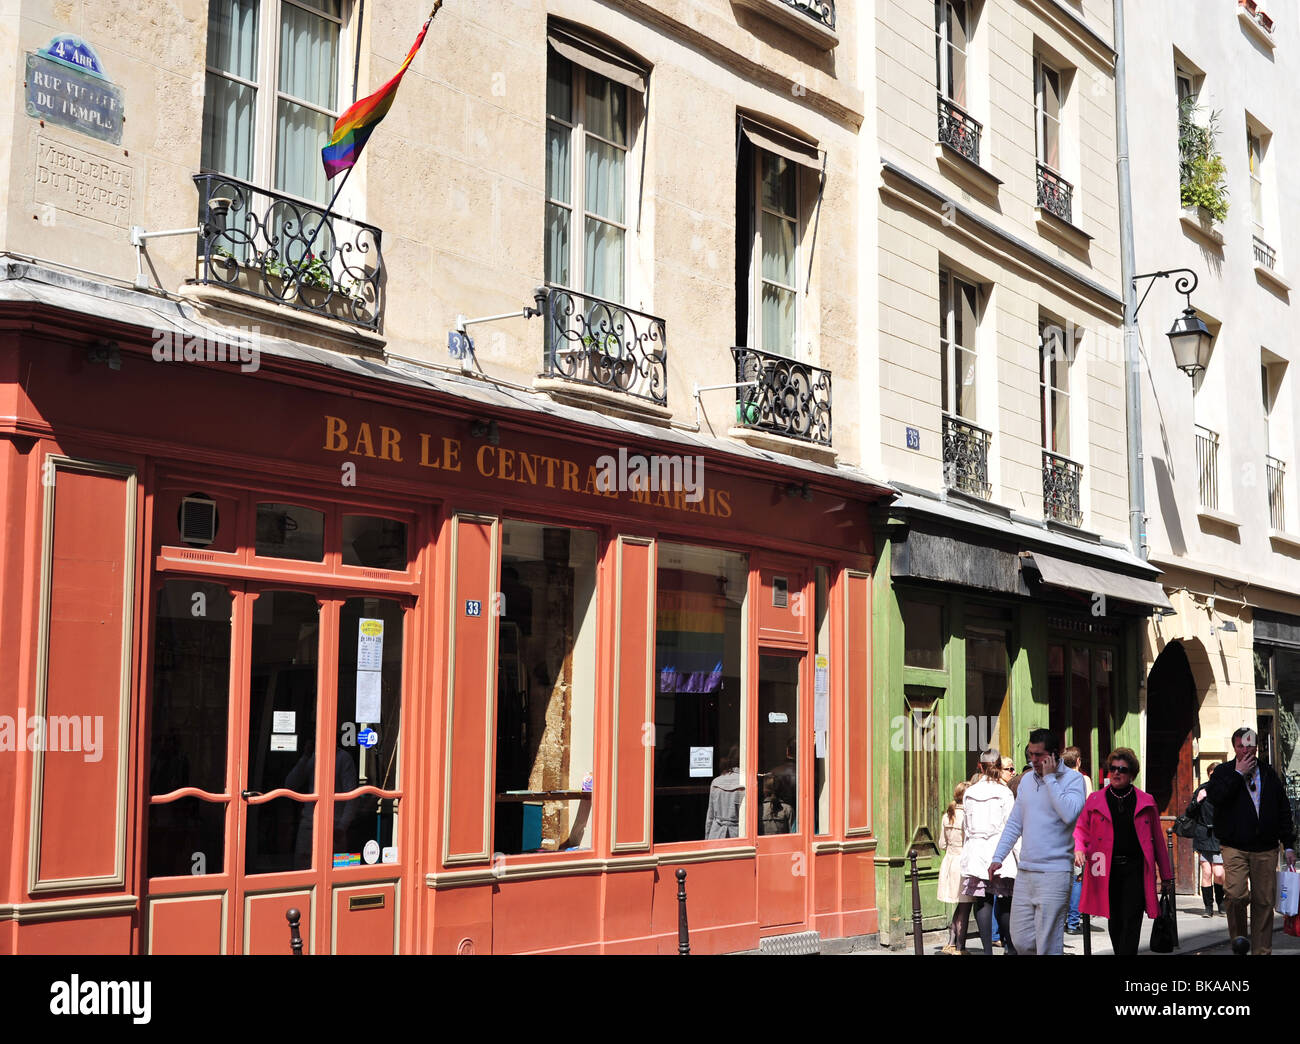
[202, 0, 343, 203]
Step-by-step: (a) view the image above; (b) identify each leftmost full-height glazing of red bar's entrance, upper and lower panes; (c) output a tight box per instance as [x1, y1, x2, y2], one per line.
[148, 580, 233, 878]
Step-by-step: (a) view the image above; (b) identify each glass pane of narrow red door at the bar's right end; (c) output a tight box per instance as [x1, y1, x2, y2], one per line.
[758, 655, 800, 835]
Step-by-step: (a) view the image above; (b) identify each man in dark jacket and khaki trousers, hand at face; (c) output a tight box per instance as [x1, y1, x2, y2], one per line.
[1206, 728, 1296, 953]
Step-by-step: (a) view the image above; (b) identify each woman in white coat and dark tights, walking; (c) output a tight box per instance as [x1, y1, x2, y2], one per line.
[957, 748, 1015, 956]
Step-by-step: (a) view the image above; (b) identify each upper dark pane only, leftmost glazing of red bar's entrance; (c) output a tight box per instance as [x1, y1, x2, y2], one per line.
[150, 580, 231, 795]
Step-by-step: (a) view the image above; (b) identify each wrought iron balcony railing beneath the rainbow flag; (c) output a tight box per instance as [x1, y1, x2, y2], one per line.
[194, 174, 384, 330]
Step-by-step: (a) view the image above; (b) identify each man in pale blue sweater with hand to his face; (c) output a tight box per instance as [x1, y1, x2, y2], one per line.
[988, 728, 1087, 953]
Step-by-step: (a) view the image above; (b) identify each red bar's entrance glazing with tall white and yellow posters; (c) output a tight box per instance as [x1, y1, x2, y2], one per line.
[333, 598, 403, 866]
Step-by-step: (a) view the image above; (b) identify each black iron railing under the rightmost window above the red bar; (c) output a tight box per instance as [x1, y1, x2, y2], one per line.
[732, 348, 831, 446]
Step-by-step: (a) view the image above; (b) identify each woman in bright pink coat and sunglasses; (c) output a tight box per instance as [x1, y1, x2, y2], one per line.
[1074, 746, 1174, 954]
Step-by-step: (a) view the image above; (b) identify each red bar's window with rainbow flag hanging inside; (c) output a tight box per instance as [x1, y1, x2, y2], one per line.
[654, 543, 748, 844]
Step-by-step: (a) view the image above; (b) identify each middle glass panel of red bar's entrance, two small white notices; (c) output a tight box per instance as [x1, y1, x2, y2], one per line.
[244, 590, 321, 874]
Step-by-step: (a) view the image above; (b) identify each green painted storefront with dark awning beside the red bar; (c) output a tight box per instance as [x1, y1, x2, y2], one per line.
[872, 497, 1162, 946]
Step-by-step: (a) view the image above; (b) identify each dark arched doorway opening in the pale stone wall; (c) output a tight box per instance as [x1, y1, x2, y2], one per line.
[1141, 641, 1200, 892]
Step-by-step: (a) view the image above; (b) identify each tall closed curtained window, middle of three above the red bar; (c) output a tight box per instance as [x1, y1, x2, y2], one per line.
[543, 52, 629, 304]
